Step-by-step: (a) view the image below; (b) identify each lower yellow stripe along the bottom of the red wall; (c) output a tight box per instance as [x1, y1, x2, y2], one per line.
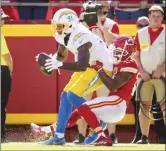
[6, 113, 154, 125]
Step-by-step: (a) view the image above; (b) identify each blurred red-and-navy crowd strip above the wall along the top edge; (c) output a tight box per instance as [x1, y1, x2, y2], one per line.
[1, 0, 165, 22]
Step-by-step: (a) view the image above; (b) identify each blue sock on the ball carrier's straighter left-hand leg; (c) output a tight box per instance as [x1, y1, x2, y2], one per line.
[56, 92, 73, 133]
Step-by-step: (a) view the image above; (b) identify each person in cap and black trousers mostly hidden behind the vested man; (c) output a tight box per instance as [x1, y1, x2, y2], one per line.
[132, 16, 166, 143]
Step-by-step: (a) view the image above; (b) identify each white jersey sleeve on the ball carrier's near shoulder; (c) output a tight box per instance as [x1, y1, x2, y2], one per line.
[73, 32, 91, 49]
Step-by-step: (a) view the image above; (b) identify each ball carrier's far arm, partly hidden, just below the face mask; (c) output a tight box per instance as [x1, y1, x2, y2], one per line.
[55, 44, 68, 62]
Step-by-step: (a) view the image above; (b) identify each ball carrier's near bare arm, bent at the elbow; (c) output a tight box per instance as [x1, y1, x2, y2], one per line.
[59, 42, 92, 72]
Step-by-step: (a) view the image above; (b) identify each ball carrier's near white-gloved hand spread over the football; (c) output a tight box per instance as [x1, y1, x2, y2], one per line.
[44, 57, 63, 72]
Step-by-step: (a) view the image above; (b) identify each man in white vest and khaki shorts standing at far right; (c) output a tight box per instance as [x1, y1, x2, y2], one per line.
[135, 5, 165, 144]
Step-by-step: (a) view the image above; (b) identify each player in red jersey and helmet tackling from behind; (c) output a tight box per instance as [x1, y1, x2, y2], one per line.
[73, 36, 138, 145]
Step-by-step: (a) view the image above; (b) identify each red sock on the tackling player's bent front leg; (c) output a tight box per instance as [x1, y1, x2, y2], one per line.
[78, 104, 103, 134]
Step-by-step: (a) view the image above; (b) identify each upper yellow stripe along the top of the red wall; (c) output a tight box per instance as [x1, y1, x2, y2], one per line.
[2, 24, 137, 37]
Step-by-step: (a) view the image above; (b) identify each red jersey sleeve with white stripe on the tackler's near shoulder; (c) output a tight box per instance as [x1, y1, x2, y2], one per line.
[120, 62, 138, 74]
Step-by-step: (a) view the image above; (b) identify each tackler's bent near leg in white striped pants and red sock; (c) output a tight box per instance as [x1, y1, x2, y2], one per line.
[78, 96, 126, 144]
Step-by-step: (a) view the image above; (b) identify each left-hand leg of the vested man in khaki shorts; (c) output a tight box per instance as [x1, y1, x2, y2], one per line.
[137, 80, 154, 144]
